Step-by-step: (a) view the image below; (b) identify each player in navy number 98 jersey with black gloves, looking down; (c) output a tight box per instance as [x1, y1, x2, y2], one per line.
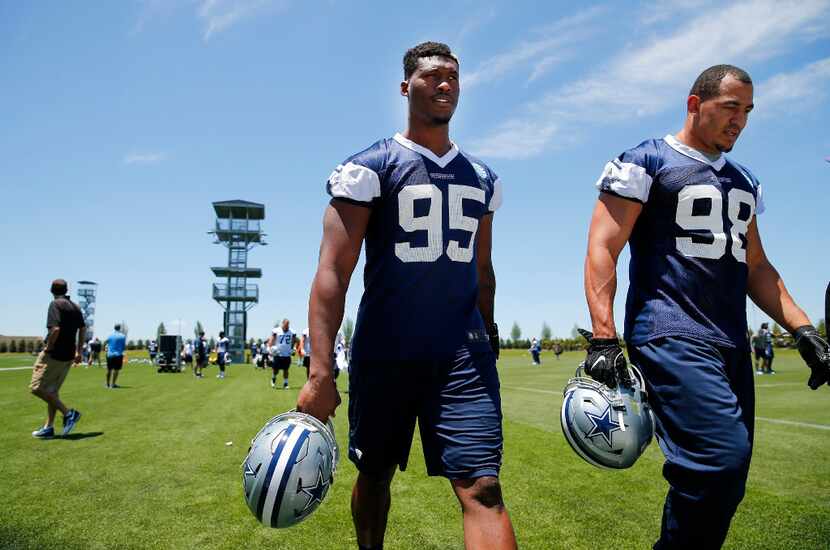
[585, 65, 830, 549]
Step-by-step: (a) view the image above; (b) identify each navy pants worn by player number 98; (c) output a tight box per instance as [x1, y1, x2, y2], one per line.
[628, 337, 755, 549]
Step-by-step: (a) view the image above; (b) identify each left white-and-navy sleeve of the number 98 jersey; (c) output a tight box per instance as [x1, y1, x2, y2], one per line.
[596, 141, 658, 204]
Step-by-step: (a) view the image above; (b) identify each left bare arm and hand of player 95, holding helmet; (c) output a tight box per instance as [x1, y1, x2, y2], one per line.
[297, 200, 371, 422]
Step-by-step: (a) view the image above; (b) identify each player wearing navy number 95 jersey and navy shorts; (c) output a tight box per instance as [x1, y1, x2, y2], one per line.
[297, 42, 516, 549]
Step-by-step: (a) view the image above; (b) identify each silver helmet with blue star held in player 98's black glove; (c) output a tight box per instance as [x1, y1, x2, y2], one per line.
[560, 364, 654, 469]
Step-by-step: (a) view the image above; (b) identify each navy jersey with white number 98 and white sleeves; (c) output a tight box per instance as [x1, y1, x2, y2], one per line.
[597, 135, 764, 347]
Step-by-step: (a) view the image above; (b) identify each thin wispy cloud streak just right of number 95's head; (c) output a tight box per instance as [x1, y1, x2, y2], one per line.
[461, 6, 605, 90]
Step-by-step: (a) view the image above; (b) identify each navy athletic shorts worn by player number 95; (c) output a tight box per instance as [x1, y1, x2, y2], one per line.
[349, 347, 503, 479]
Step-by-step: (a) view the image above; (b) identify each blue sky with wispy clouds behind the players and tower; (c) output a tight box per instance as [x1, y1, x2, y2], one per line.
[0, 0, 830, 338]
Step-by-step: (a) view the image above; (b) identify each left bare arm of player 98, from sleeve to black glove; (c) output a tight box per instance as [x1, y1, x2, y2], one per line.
[585, 193, 643, 338]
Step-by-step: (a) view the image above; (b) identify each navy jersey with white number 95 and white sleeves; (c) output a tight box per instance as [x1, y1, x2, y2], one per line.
[327, 134, 501, 360]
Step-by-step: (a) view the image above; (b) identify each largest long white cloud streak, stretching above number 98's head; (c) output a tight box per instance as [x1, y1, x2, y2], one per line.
[472, 0, 830, 158]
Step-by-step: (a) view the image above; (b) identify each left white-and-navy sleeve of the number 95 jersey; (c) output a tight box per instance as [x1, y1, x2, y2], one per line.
[326, 142, 386, 207]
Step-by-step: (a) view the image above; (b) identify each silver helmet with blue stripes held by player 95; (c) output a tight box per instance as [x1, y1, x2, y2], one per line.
[242, 411, 340, 527]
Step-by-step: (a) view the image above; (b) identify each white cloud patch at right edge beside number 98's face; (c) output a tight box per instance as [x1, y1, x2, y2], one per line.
[755, 57, 830, 114]
